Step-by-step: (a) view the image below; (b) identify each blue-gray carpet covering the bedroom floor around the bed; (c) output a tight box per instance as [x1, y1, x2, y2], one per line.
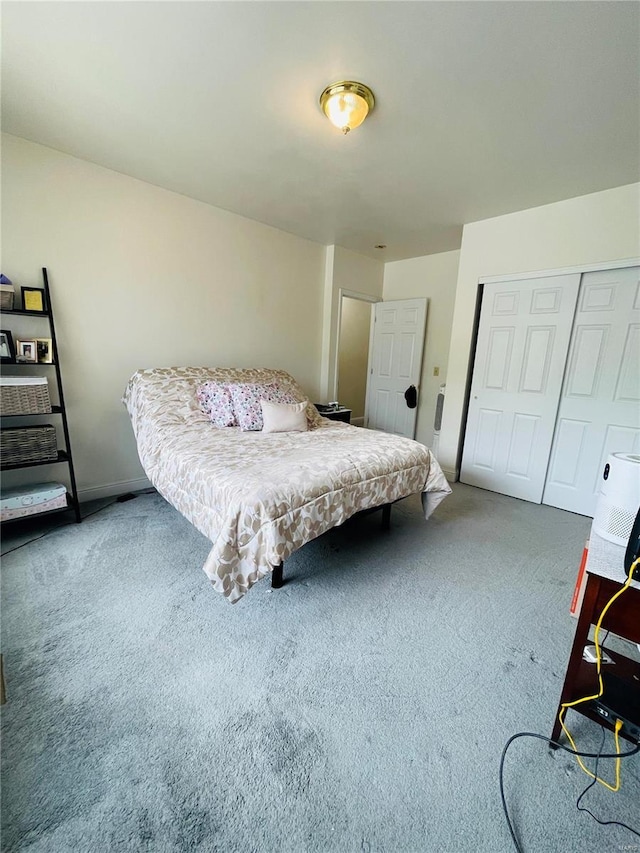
[2, 485, 640, 853]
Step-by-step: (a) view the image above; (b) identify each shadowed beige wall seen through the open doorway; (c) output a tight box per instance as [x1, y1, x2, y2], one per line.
[337, 296, 373, 422]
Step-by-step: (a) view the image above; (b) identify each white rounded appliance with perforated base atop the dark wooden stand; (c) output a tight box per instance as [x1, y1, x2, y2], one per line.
[592, 453, 640, 547]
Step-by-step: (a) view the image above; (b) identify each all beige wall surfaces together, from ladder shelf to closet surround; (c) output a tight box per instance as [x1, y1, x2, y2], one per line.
[5, 135, 640, 497]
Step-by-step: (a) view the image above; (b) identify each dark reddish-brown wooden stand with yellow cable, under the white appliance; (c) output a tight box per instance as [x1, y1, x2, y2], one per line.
[551, 574, 640, 741]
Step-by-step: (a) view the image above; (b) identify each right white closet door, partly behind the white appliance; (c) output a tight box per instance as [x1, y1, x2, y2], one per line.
[542, 267, 640, 517]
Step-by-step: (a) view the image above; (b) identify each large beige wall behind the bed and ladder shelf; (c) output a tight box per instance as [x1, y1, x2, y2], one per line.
[1, 135, 325, 497]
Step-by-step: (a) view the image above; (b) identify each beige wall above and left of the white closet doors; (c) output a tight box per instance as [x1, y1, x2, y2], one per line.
[440, 184, 640, 472]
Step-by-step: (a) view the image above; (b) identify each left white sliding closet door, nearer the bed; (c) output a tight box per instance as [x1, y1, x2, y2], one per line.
[460, 273, 580, 503]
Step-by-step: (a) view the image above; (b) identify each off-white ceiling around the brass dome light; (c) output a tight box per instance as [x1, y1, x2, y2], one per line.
[2, 0, 640, 260]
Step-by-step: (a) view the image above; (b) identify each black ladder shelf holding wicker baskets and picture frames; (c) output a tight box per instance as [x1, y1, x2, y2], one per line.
[0, 267, 82, 524]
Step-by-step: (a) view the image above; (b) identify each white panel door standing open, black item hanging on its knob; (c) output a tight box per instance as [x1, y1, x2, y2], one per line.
[365, 299, 427, 438]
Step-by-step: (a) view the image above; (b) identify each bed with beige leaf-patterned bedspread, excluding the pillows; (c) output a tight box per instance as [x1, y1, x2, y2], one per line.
[123, 367, 451, 603]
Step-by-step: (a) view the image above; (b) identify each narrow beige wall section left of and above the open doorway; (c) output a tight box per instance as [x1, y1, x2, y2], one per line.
[319, 246, 384, 403]
